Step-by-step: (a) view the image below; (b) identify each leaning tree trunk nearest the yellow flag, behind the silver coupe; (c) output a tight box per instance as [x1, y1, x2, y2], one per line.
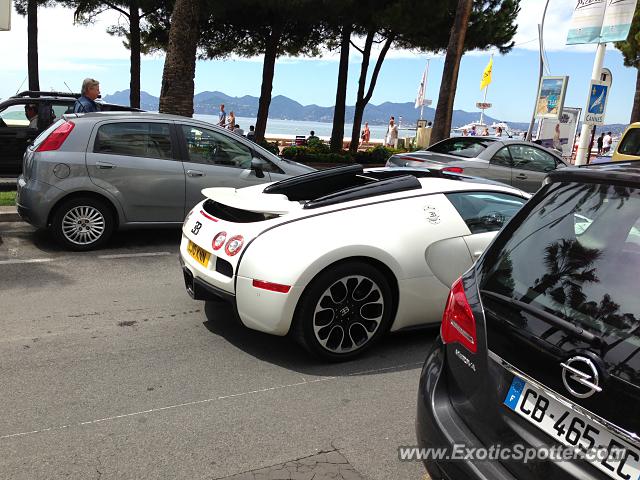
[431, 0, 473, 144]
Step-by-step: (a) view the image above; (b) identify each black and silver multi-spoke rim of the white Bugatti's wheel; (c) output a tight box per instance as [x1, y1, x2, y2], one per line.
[313, 275, 385, 353]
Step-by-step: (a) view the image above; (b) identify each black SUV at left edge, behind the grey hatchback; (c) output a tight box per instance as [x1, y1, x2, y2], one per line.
[0, 91, 138, 176]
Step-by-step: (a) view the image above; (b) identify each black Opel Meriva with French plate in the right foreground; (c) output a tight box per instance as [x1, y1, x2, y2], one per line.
[416, 164, 640, 480]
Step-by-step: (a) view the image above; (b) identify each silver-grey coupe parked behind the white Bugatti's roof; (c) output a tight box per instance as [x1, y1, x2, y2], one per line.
[387, 137, 566, 193]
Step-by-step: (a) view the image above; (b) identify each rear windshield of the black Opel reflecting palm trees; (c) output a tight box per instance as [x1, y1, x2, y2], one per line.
[479, 183, 640, 378]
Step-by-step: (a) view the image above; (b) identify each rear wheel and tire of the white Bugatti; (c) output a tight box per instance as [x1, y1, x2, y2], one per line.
[293, 261, 395, 362]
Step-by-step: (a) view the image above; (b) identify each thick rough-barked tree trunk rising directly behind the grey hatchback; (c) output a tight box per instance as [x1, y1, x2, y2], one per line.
[159, 0, 200, 117]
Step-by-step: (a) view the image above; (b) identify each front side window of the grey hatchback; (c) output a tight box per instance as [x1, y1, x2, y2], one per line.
[182, 125, 252, 169]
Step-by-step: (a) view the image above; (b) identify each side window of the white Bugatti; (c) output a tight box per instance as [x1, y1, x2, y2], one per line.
[447, 192, 526, 234]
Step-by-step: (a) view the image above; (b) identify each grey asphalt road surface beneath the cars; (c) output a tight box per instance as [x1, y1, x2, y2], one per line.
[0, 223, 435, 480]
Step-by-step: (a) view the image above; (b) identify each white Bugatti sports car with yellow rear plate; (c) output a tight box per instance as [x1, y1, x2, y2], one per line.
[180, 165, 528, 360]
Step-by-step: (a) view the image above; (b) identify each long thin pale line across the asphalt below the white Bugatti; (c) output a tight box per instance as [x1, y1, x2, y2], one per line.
[0, 362, 422, 440]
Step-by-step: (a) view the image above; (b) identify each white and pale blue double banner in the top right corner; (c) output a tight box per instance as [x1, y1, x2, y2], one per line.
[567, 0, 637, 45]
